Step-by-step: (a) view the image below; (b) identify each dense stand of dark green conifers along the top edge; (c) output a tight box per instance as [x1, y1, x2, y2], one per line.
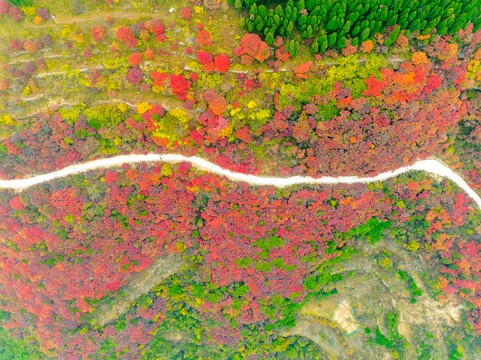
[229, 0, 481, 55]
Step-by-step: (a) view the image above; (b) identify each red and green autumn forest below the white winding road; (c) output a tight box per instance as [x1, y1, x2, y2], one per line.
[0, 163, 481, 358]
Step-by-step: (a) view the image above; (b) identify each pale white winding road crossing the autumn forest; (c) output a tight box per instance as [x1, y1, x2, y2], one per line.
[0, 154, 481, 209]
